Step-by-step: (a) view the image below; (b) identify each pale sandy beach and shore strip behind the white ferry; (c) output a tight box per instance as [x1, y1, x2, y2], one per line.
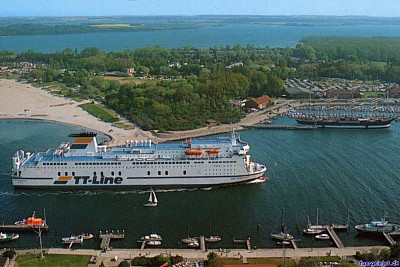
[0, 79, 294, 144]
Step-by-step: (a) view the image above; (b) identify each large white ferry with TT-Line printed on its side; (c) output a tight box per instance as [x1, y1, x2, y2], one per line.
[12, 131, 266, 189]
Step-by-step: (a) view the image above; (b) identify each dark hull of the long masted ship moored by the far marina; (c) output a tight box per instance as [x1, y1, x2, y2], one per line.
[296, 119, 393, 129]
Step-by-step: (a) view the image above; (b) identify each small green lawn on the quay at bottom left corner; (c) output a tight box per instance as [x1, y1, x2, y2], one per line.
[17, 254, 90, 267]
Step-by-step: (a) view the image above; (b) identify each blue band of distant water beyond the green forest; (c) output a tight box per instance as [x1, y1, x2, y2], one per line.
[0, 22, 400, 52]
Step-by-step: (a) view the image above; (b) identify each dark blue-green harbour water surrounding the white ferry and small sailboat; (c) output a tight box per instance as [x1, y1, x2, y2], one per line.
[0, 121, 400, 248]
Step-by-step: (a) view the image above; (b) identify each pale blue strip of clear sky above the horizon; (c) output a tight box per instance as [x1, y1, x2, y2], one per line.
[0, 0, 400, 17]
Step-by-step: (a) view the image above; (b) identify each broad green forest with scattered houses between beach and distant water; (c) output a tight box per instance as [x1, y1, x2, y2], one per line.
[0, 37, 400, 131]
